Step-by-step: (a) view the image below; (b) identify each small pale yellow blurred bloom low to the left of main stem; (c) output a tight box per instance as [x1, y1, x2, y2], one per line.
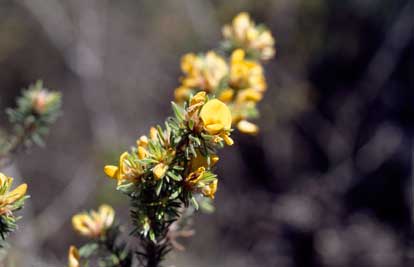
[72, 205, 115, 238]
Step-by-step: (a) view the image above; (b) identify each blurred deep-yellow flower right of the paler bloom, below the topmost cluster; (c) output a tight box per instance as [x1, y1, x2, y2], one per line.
[230, 49, 267, 93]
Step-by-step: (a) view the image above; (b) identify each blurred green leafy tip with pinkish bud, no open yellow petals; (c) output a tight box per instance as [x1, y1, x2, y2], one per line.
[0, 81, 61, 169]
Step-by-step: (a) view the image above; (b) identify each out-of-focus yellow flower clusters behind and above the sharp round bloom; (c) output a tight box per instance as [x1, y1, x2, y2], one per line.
[174, 13, 274, 134]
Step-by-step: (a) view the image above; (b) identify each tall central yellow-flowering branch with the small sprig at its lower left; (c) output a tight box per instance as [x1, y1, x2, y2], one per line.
[68, 13, 274, 267]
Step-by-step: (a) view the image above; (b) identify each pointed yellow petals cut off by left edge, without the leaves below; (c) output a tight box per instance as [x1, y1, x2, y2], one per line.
[0, 172, 27, 215]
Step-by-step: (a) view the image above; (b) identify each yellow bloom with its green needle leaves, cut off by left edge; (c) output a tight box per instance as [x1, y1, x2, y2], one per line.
[0, 172, 28, 247]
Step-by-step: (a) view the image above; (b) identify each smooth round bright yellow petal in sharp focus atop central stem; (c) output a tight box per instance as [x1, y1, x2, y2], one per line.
[199, 99, 231, 135]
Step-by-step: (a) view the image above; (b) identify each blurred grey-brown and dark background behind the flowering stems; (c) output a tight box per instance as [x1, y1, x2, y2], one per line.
[0, 0, 414, 267]
